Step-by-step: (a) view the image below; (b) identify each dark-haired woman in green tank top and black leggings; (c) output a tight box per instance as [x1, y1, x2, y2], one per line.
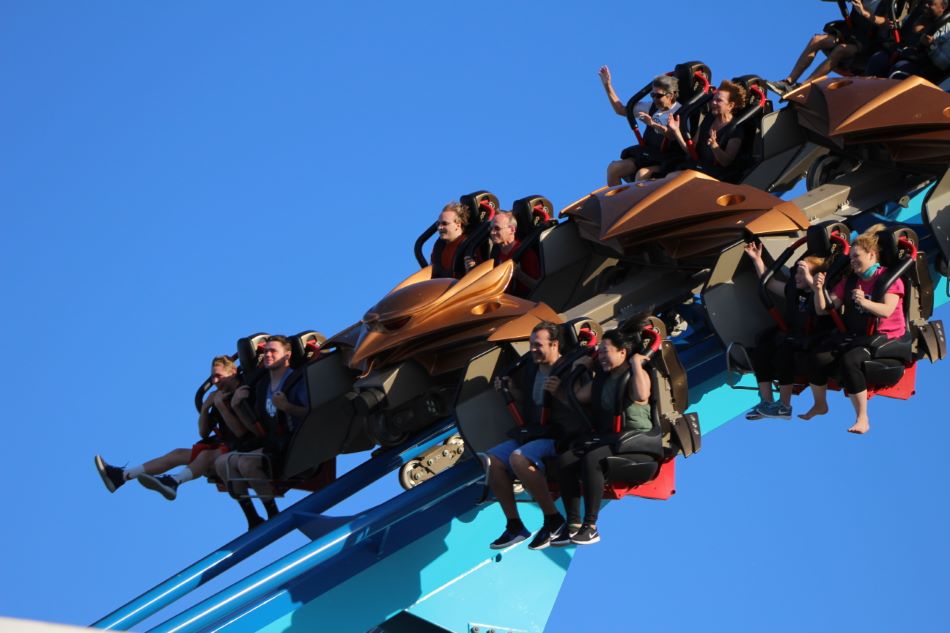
[551, 330, 653, 546]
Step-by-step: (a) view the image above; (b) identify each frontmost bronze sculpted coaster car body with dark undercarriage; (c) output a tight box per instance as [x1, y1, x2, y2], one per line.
[330, 261, 557, 446]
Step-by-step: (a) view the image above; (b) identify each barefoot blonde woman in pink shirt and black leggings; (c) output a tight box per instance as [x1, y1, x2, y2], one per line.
[799, 224, 907, 433]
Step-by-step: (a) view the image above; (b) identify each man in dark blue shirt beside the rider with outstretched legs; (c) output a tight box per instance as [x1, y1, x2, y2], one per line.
[215, 335, 310, 529]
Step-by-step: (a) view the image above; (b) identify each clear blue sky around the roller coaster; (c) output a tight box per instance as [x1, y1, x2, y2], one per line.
[0, 0, 950, 631]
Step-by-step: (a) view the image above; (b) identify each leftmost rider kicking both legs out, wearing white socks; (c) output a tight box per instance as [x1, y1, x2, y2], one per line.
[95, 356, 240, 500]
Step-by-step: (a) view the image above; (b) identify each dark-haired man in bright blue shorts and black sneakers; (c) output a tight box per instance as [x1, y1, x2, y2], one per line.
[482, 321, 577, 549]
